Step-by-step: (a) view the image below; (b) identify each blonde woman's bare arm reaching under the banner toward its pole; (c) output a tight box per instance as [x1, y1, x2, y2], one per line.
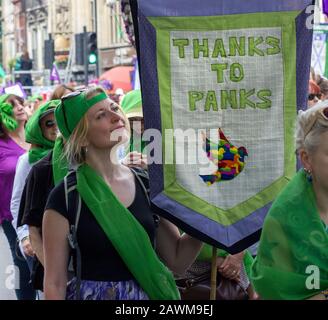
[157, 218, 203, 274]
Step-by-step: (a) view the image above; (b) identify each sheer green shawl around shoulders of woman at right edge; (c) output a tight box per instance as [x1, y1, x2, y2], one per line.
[251, 170, 328, 300]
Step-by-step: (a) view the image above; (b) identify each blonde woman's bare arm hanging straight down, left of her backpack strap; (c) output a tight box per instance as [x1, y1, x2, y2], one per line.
[42, 210, 69, 300]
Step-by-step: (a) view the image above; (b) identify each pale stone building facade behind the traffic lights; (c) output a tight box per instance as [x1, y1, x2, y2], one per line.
[0, 0, 135, 72]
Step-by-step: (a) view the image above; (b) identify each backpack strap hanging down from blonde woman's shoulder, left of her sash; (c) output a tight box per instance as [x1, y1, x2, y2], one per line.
[64, 171, 82, 300]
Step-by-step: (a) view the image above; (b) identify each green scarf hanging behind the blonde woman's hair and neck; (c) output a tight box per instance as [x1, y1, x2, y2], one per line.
[52, 137, 68, 185]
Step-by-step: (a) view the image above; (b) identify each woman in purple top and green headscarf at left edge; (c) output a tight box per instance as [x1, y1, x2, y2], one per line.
[0, 94, 35, 300]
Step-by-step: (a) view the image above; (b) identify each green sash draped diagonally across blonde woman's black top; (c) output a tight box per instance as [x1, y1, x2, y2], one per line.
[77, 164, 179, 300]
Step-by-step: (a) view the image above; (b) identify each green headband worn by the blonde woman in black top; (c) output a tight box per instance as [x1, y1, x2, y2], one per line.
[55, 91, 108, 139]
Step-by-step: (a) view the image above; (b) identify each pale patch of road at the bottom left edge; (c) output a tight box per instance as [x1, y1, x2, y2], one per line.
[0, 227, 16, 300]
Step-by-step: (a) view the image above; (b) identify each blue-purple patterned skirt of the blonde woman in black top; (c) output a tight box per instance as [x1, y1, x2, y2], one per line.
[66, 278, 149, 300]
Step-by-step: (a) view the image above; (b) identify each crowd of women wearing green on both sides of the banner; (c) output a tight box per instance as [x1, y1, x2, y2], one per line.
[0, 77, 328, 300]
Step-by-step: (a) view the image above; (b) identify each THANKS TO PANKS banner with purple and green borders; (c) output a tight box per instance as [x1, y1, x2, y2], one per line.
[132, 0, 312, 253]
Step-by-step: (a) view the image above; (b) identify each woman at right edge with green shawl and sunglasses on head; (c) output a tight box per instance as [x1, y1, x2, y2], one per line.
[251, 101, 328, 300]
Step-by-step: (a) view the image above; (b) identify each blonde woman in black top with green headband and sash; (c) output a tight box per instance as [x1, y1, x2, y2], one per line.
[43, 88, 202, 300]
